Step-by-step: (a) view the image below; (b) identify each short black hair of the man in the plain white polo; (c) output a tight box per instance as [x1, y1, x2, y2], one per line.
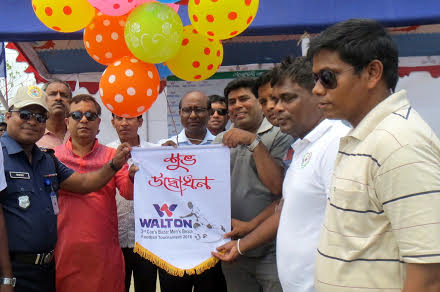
[271, 57, 315, 92]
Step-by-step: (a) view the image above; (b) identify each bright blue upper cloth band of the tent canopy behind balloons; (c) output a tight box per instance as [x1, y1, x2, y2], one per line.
[0, 0, 440, 41]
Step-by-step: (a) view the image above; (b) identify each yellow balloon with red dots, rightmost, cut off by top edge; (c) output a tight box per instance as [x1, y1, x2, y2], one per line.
[188, 0, 258, 40]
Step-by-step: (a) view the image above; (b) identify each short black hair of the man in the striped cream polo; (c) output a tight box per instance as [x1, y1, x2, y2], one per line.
[307, 19, 399, 91]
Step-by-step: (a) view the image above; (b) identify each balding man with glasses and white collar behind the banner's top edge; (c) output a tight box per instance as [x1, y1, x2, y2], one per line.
[158, 91, 215, 145]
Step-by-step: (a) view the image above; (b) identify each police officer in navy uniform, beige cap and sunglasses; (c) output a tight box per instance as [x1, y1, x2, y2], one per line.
[0, 86, 130, 292]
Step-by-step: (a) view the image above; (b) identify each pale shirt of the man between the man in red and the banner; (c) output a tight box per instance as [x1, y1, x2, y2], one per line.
[107, 139, 160, 248]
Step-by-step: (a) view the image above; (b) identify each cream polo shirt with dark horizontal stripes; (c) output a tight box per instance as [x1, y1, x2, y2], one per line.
[315, 90, 440, 292]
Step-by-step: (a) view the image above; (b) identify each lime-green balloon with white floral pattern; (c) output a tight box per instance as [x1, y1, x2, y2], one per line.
[125, 2, 183, 63]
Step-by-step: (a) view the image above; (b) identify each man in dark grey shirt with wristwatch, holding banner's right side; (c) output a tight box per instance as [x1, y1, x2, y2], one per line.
[215, 78, 292, 292]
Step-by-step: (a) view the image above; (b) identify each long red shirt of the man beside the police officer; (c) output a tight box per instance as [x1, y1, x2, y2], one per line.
[55, 139, 133, 292]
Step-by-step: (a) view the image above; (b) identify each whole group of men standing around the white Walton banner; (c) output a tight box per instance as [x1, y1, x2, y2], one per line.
[0, 19, 440, 292]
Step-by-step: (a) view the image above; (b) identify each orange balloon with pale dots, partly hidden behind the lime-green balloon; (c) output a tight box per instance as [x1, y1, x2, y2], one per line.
[84, 12, 131, 65]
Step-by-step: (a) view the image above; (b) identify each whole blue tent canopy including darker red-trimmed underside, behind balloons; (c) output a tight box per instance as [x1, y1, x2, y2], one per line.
[0, 0, 440, 85]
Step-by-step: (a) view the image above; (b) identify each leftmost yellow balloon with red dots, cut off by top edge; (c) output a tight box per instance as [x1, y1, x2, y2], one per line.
[32, 0, 95, 32]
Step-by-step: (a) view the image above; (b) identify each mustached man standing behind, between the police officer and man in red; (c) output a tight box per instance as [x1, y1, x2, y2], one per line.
[37, 80, 72, 149]
